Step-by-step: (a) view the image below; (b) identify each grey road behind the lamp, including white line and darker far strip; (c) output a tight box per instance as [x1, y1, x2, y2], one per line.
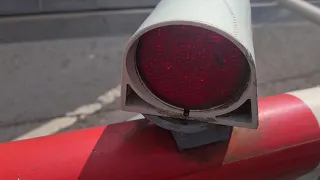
[0, 1, 320, 142]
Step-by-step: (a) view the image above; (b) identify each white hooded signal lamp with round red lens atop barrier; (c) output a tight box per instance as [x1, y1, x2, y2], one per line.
[121, 0, 258, 134]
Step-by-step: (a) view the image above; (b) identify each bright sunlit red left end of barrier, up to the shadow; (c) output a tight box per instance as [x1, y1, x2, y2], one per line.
[0, 127, 105, 180]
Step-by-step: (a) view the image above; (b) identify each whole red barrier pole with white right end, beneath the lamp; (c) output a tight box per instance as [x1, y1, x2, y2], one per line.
[0, 88, 320, 180]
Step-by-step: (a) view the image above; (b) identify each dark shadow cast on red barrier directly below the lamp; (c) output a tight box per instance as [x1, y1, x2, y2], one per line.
[79, 120, 229, 180]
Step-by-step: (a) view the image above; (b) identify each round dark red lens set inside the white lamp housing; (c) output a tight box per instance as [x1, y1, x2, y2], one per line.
[136, 25, 250, 110]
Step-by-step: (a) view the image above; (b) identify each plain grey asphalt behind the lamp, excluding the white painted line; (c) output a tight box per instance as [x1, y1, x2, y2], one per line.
[0, 21, 320, 141]
